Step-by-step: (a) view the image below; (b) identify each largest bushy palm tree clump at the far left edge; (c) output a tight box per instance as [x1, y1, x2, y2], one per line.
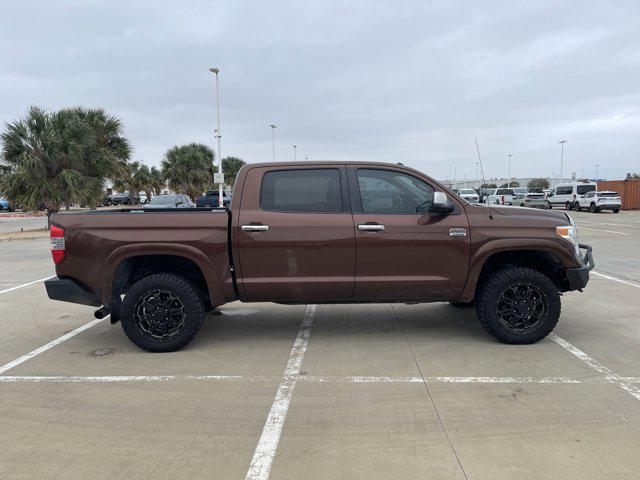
[0, 107, 130, 222]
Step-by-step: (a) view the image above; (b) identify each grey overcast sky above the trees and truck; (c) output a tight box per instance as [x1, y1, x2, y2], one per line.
[0, 0, 640, 179]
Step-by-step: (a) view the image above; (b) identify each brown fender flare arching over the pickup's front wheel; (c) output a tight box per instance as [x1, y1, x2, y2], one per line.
[460, 238, 579, 302]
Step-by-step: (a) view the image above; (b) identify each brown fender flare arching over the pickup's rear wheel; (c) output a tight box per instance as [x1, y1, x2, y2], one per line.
[100, 243, 224, 306]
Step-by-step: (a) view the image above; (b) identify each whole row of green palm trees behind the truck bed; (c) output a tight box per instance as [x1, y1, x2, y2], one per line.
[0, 107, 245, 215]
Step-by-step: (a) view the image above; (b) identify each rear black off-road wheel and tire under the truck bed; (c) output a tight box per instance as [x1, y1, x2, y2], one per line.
[120, 273, 205, 352]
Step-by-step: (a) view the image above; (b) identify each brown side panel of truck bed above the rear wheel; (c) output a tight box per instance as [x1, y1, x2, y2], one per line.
[52, 208, 235, 306]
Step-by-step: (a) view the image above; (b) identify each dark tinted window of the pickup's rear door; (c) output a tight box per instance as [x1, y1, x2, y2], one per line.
[260, 168, 344, 213]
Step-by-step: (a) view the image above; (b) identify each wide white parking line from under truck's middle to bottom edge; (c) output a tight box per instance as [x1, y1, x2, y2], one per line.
[245, 305, 316, 480]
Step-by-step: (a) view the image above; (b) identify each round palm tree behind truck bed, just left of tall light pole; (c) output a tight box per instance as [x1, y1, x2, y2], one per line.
[162, 143, 214, 199]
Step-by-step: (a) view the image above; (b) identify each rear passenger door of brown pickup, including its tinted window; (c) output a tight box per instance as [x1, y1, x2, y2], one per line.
[234, 165, 355, 302]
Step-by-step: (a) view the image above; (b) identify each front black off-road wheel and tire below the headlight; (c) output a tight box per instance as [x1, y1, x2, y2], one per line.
[476, 267, 560, 345]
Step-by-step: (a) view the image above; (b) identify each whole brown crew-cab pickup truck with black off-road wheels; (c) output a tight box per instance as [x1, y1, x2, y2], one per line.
[45, 162, 593, 351]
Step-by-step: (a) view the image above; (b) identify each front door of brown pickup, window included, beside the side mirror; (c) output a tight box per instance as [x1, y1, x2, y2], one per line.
[348, 167, 470, 301]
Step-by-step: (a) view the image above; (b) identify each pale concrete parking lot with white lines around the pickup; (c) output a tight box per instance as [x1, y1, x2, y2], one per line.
[0, 212, 640, 479]
